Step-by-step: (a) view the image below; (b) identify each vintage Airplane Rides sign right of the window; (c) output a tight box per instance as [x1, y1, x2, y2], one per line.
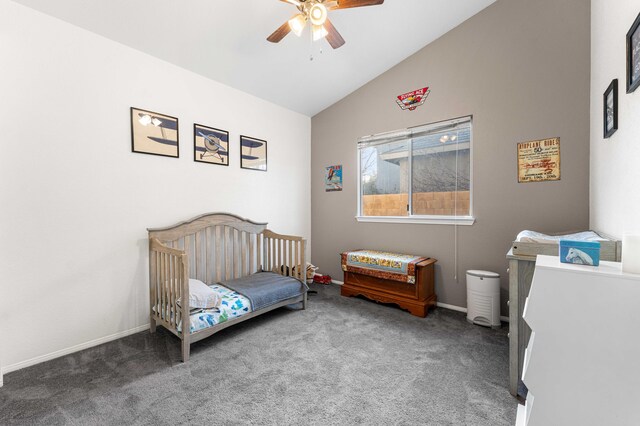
[518, 138, 560, 183]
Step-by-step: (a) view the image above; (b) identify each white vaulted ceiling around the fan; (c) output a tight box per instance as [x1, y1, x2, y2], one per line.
[14, 0, 495, 116]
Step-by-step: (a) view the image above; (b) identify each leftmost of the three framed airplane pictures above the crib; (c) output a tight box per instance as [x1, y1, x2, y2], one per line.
[131, 107, 180, 158]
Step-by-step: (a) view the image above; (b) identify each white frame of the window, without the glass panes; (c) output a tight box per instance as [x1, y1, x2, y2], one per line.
[355, 115, 476, 225]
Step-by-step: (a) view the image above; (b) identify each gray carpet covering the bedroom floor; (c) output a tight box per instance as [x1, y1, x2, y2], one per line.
[0, 285, 516, 426]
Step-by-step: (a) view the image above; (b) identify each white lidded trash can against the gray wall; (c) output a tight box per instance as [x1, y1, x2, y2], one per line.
[467, 270, 500, 328]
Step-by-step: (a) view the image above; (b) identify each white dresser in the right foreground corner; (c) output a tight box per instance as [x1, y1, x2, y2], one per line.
[516, 256, 640, 426]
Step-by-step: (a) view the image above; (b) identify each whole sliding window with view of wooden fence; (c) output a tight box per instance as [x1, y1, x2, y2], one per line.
[357, 117, 474, 225]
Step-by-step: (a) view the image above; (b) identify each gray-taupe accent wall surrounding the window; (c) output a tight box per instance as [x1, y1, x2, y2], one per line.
[311, 0, 590, 315]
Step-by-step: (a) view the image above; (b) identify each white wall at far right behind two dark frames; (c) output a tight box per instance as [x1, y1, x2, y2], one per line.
[590, 0, 640, 237]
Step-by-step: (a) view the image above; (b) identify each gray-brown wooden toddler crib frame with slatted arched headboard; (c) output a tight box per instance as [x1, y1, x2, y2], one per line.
[148, 213, 307, 362]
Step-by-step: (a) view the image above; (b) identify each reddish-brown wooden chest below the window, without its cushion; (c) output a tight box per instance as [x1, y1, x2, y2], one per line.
[340, 259, 437, 318]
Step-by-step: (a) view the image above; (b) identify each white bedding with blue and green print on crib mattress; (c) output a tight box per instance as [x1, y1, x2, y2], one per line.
[178, 284, 252, 333]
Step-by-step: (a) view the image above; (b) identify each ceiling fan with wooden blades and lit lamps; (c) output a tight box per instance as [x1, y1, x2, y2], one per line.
[267, 0, 384, 49]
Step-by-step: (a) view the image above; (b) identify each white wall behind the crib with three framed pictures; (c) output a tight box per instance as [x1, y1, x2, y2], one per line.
[0, 0, 310, 372]
